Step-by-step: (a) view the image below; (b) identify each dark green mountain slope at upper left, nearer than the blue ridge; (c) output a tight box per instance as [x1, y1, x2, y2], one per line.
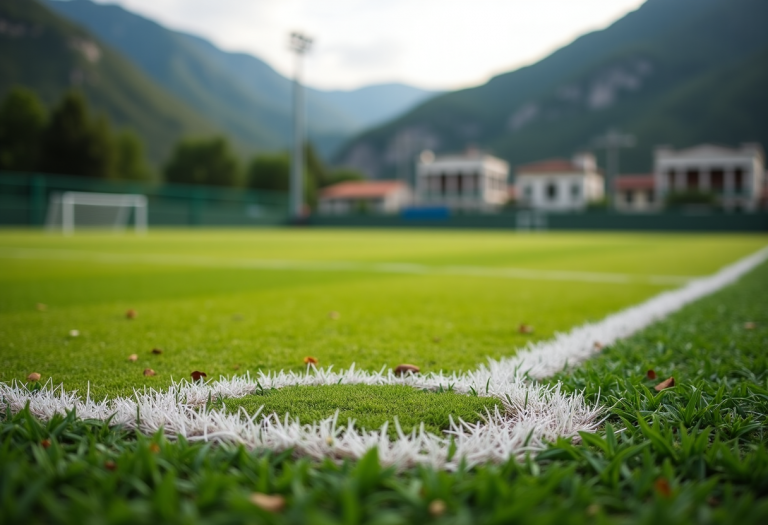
[0, 0, 216, 164]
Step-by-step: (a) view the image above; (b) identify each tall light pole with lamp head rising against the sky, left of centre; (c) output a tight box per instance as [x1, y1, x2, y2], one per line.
[291, 33, 312, 222]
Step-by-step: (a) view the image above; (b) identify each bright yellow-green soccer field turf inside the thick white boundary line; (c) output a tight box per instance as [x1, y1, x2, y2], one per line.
[0, 229, 768, 397]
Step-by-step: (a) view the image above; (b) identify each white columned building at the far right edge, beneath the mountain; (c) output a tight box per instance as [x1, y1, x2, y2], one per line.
[654, 144, 765, 210]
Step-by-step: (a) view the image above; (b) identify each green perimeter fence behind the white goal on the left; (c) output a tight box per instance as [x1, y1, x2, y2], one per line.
[0, 172, 288, 226]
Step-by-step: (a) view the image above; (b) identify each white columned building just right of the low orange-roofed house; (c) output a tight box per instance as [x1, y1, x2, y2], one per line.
[416, 151, 509, 211]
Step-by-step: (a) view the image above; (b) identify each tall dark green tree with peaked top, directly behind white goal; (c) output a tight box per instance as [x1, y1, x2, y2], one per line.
[41, 92, 115, 178]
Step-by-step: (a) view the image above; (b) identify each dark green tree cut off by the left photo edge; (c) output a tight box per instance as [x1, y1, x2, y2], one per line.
[0, 88, 46, 171]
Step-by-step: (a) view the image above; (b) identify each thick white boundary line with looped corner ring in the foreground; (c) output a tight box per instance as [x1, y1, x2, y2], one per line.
[0, 244, 768, 470]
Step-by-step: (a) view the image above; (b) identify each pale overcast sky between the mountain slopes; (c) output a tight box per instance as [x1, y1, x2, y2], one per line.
[90, 0, 643, 89]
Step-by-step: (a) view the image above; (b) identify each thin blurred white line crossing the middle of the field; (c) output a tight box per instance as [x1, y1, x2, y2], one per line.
[0, 248, 696, 286]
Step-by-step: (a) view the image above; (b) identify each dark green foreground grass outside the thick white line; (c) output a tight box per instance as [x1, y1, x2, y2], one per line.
[0, 253, 768, 525]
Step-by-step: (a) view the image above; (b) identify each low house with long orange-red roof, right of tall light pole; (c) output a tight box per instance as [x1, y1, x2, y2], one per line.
[318, 180, 413, 215]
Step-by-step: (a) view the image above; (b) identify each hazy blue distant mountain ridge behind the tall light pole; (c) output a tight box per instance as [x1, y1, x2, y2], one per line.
[47, 0, 433, 159]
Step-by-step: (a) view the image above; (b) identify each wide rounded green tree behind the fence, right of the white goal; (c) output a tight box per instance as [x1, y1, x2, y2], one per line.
[164, 137, 241, 186]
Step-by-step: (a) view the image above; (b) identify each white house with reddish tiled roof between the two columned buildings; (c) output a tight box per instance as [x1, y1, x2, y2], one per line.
[515, 153, 605, 211]
